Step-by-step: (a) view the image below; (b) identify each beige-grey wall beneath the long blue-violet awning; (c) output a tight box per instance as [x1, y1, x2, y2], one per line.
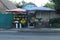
[36, 12, 56, 21]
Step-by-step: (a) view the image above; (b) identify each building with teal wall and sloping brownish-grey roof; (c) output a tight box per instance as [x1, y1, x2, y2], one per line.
[0, 0, 17, 28]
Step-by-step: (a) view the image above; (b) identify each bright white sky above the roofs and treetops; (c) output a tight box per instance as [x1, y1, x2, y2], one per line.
[10, 0, 49, 7]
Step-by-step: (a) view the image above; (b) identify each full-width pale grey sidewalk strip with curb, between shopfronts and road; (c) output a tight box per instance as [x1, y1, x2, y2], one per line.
[0, 28, 60, 33]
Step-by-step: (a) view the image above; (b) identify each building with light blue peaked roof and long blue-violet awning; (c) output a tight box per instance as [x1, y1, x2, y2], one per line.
[23, 3, 57, 28]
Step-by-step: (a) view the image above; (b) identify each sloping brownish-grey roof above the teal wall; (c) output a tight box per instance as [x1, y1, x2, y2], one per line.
[0, 0, 17, 10]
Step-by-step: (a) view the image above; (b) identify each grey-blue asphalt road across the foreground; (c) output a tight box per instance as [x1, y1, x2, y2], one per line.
[0, 31, 60, 40]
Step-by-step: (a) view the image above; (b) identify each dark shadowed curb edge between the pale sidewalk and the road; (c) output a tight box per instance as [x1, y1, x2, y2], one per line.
[18, 29, 60, 33]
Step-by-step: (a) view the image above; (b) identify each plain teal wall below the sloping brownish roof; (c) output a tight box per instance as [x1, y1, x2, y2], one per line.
[0, 12, 13, 28]
